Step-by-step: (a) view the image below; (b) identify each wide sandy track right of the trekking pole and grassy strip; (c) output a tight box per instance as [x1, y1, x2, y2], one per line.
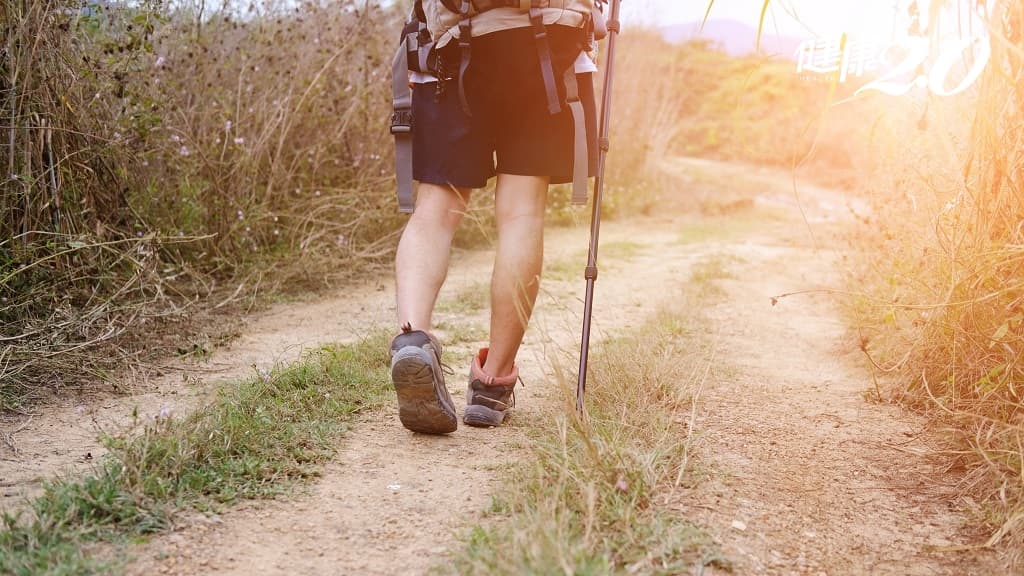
[663, 158, 1004, 576]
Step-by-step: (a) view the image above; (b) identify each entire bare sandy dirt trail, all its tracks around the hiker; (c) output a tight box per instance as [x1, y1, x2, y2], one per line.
[0, 160, 999, 576]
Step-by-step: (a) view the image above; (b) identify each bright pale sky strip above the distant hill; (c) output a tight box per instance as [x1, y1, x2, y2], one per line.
[622, 0, 908, 40]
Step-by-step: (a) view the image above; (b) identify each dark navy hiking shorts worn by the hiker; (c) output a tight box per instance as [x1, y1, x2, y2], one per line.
[413, 26, 597, 189]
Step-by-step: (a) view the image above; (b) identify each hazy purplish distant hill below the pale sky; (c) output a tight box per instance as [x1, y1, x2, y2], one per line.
[660, 19, 803, 59]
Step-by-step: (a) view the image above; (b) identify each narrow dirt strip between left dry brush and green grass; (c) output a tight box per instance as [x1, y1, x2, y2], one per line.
[0, 264, 393, 502]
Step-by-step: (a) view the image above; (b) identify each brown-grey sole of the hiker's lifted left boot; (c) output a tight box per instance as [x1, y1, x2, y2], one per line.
[391, 346, 459, 434]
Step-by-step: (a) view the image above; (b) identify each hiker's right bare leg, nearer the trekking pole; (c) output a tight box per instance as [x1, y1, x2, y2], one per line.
[483, 174, 548, 377]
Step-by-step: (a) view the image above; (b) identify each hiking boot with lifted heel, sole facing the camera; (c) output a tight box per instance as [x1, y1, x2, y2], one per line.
[391, 325, 459, 434]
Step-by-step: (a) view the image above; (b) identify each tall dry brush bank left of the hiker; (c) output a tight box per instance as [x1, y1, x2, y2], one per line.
[0, 0, 400, 409]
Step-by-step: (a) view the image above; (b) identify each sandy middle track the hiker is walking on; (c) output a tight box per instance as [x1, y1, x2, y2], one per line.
[117, 217, 697, 575]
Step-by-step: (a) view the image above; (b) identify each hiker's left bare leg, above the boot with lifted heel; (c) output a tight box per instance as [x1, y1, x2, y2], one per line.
[394, 183, 470, 330]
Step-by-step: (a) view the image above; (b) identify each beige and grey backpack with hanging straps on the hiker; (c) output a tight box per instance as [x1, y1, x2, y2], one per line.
[391, 0, 607, 213]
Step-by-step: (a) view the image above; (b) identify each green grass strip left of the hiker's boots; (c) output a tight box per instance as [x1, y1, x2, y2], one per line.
[0, 334, 389, 575]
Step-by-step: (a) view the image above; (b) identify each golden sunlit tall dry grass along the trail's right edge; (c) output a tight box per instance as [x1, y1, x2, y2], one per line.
[843, 2, 1024, 570]
